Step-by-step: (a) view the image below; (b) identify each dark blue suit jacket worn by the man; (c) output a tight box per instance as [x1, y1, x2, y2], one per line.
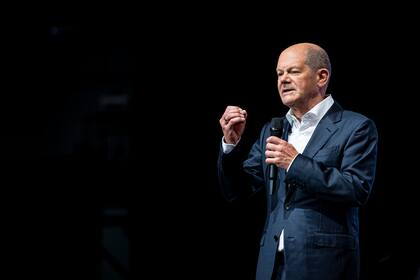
[218, 103, 378, 280]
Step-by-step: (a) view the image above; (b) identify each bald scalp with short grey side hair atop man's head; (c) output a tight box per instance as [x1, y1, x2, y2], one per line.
[282, 43, 331, 76]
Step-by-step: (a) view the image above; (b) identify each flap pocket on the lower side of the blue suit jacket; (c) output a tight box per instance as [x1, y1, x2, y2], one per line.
[312, 233, 356, 250]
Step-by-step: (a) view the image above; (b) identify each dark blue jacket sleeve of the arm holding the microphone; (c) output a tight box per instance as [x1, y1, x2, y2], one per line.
[286, 119, 378, 206]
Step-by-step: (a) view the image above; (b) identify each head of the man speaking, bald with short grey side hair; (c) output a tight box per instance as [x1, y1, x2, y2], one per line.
[276, 43, 331, 117]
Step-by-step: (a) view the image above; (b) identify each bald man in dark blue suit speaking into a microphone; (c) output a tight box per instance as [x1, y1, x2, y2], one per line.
[218, 43, 378, 280]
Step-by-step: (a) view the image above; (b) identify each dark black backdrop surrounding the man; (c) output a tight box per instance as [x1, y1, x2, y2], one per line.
[1, 4, 419, 279]
